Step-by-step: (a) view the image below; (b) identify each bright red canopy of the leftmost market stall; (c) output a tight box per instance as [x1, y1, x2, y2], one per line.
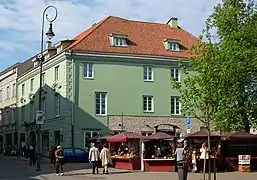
[107, 132, 142, 142]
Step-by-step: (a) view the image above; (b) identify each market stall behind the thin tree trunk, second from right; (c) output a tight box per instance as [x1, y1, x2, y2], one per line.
[185, 131, 221, 172]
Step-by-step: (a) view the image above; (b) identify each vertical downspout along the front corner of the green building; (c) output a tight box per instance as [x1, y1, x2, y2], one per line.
[69, 50, 75, 148]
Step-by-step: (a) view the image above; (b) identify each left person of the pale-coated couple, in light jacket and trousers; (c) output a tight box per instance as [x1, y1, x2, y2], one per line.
[88, 143, 100, 174]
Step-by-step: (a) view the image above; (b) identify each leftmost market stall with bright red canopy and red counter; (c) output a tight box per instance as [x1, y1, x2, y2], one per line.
[107, 132, 142, 170]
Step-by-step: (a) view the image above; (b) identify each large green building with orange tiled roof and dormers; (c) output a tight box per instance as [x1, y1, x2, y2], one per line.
[17, 16, 201, 153]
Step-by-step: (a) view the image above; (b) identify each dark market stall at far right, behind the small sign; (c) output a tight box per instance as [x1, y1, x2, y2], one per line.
[222, 131, 257, 172]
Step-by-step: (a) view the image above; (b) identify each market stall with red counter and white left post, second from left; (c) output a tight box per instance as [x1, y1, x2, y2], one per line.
[141, 132, 176, 172]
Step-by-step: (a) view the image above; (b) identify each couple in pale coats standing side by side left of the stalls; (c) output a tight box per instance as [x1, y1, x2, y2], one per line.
[88, 143, 112, 174]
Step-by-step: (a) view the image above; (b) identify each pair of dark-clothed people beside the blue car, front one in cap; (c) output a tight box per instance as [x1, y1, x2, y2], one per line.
[49, 146, 65, 176]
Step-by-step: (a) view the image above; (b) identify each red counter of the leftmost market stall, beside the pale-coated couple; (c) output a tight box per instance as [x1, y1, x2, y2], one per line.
[111, 156, 141, 170]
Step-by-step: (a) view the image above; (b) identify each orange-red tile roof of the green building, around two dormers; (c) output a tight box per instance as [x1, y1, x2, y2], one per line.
[67, 16, 197, 58]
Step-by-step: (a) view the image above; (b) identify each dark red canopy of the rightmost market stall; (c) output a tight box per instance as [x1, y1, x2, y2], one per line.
[223, 131, 257, 140]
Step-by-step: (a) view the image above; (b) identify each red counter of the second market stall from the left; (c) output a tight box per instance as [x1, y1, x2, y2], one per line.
[143, 159, 176, 172]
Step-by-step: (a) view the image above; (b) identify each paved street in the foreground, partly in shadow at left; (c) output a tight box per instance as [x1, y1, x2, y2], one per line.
[0, 158, 257, 180]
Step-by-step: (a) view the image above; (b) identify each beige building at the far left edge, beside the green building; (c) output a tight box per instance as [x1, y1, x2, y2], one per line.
[0, 63, 20, 145]
